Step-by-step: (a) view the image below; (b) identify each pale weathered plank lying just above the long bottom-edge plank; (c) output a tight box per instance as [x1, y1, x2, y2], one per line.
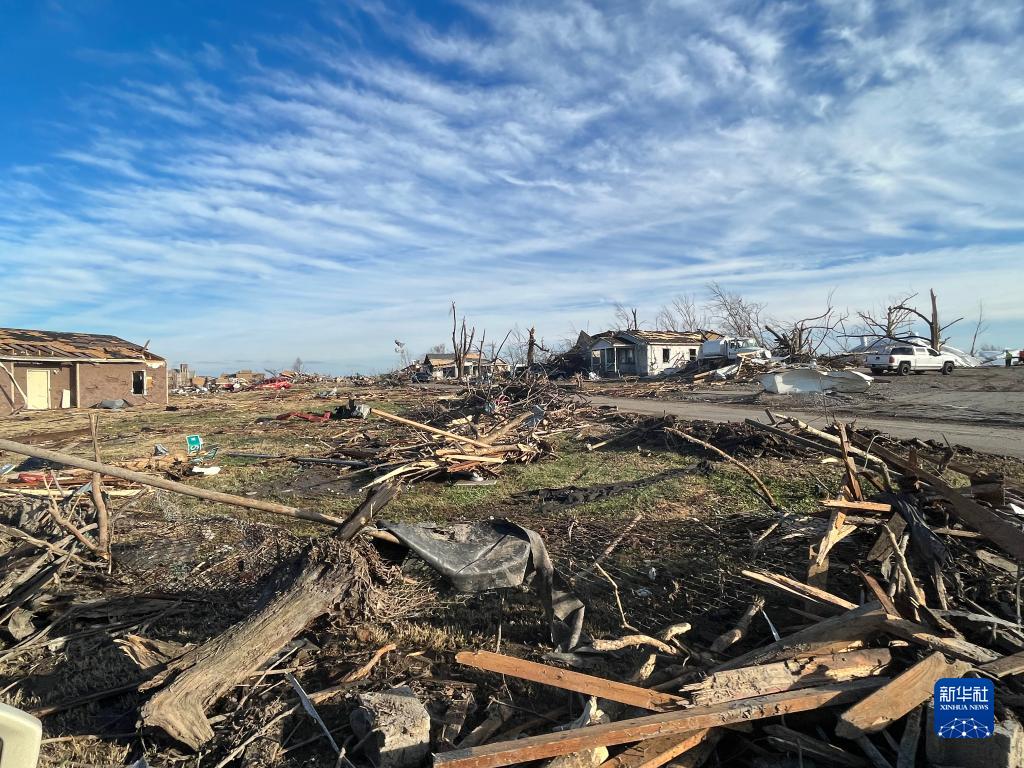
[680, 648, 892, 706]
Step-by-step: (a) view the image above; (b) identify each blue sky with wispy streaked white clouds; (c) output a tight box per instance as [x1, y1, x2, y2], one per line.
[0, 0, 1024, 373]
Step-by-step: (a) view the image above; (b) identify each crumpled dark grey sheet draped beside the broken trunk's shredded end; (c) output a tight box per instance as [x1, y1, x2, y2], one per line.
[380, 520, 584, 648]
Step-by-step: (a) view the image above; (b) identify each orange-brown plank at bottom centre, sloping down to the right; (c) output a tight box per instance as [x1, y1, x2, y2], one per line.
[455, 650, 685, 711]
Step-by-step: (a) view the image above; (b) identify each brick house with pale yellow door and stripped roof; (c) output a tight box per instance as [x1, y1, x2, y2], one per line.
[0, 328, 167, 416]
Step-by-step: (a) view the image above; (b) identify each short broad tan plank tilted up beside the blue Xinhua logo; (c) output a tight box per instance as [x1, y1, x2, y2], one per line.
[836, 652, 971, 739]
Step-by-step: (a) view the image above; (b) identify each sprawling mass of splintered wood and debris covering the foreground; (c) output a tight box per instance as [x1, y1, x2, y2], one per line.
[0, 381, 1024, 768]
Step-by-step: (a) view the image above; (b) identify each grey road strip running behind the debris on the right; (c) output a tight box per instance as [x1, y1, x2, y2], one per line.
[592, 395, 1024, 459]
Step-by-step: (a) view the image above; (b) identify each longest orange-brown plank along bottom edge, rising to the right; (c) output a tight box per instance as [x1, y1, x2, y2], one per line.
[434, 678, 885, 768]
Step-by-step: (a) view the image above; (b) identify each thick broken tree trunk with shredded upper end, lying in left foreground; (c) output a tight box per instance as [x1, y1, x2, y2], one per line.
[136, 485, 396, 749]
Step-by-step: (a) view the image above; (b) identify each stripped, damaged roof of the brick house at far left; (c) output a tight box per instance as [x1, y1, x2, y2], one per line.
[0, 328, 164, 362]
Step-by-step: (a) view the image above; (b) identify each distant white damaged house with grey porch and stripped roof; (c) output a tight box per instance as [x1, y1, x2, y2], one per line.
[588, 331, 721, 376]
